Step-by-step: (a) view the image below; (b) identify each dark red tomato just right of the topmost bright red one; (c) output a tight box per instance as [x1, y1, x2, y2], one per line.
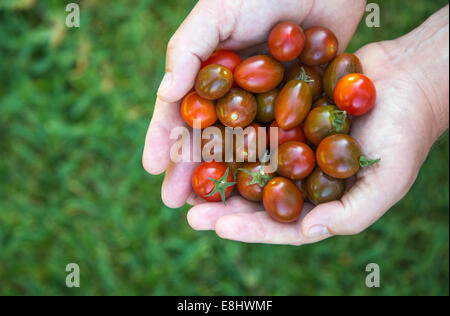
[300, 26, 339, 66]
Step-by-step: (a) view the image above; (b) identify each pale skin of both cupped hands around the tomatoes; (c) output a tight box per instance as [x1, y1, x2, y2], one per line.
[143, 0, 449, 245]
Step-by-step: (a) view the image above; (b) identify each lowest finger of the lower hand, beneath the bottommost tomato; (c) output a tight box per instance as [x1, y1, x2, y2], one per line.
[215, 204, 331, 246]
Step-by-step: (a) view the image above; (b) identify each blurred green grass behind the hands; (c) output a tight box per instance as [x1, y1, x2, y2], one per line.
[0, 0, 449, 295]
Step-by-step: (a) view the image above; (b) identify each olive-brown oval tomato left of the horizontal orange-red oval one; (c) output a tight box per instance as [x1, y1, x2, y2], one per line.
[195, 64, 233, 100]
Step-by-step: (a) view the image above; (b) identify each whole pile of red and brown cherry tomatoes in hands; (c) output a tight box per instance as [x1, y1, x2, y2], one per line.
[181, 22, 379, 222]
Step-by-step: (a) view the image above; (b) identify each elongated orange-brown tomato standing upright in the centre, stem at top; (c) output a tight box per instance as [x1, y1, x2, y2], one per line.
[275, 80, 312, 129]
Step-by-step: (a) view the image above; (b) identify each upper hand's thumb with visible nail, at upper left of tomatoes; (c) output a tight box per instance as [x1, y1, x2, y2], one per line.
[158, 1, 219, 103]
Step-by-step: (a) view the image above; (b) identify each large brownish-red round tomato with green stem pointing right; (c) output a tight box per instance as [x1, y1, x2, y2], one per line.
[316, 134, 362, 179]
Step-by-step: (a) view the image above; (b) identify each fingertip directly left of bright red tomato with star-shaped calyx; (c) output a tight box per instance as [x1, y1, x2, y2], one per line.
[161, 162, 198, 208]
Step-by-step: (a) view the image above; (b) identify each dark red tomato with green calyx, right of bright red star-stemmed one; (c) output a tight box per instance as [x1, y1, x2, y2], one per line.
[236, 161, 274, 202]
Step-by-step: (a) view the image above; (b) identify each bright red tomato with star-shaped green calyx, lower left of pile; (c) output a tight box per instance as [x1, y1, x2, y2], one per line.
[192, 161, 234, 202]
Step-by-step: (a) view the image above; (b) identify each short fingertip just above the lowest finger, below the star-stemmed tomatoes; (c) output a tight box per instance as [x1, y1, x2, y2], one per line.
[187, 196, 264, 230]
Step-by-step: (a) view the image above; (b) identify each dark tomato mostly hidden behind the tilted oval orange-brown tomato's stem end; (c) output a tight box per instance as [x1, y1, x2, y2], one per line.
[284, 64, 322, 100]
